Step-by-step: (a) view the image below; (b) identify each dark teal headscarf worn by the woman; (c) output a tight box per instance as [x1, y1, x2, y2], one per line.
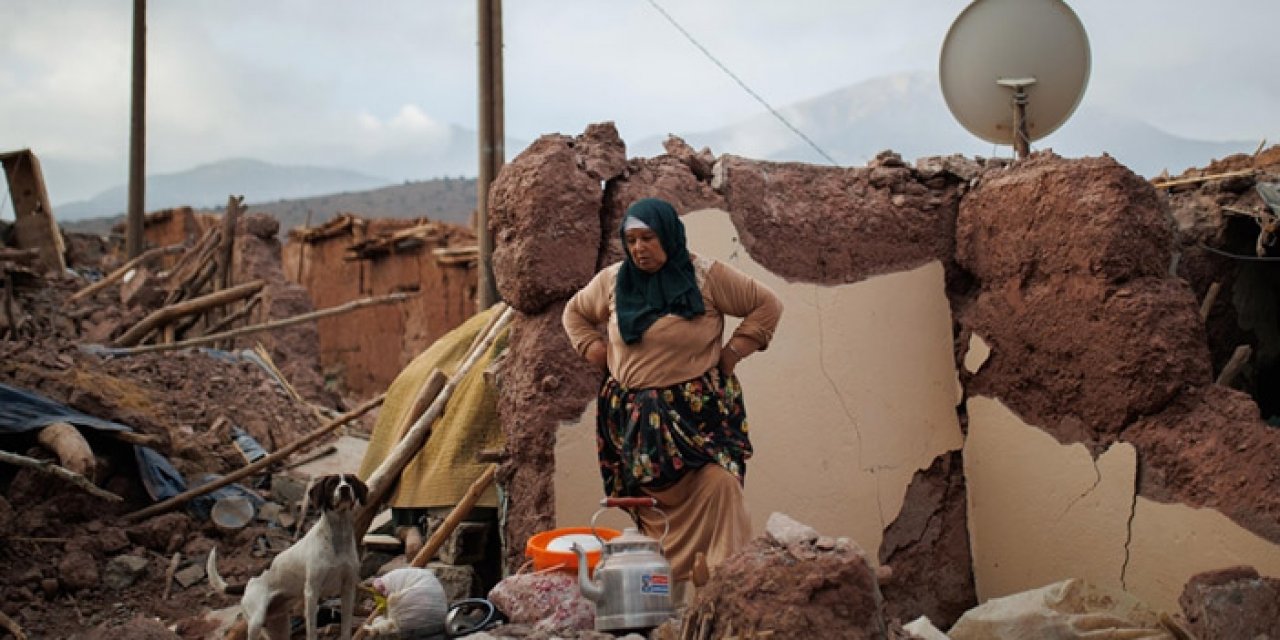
[613, 198, 705, 344]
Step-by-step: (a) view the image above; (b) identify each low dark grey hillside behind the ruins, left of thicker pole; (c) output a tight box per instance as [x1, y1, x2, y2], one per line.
[60, 178, 476, 239]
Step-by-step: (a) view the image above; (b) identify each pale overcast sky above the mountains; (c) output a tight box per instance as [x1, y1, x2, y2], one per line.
[0, 0, 1280, 207]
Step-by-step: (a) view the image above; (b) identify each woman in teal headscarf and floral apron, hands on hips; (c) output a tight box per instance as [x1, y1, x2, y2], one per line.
[563, 198, 782, 581]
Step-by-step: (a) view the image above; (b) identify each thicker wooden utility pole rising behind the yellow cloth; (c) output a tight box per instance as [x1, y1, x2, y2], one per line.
[476, 0, 506, 311]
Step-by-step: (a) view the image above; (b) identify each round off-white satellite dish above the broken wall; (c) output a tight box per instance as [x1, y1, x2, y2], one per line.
[938, 0, 1089, 157]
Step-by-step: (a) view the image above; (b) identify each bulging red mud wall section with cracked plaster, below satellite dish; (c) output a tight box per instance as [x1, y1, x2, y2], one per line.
[956, 154, 1280, 612]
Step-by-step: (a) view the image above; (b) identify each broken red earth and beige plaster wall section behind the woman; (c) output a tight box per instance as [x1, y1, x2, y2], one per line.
[490, 125, 977, 620]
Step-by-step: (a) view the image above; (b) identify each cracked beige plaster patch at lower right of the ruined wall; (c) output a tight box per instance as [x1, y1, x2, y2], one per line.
[964, 396, 1280, 612]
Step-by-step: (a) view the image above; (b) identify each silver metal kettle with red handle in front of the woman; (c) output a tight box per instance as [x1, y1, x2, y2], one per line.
[573, 498, 676, 631]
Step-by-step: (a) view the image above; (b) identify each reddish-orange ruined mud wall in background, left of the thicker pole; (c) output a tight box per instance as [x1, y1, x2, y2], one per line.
[284, 214, 477, 397]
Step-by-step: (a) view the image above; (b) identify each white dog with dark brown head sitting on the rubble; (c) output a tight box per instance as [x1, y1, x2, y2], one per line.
[206, 474, 369, 640]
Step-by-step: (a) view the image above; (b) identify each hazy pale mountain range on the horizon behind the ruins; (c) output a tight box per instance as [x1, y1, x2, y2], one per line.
[46, 72, 1256, 224]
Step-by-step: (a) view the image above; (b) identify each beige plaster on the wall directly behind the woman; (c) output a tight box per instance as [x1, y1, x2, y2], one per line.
[554, 210, 961, 554]
